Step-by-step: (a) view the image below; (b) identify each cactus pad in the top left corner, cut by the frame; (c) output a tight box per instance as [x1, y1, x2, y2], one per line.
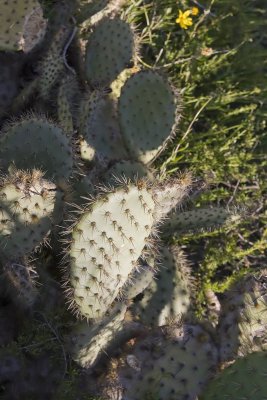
[0, 0, 47, 52]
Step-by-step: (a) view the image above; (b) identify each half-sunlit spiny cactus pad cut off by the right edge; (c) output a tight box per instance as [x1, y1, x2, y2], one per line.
[218, 269, 267, 361]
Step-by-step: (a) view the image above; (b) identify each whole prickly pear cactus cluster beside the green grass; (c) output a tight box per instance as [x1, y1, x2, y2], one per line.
[0, 0, 262, 400]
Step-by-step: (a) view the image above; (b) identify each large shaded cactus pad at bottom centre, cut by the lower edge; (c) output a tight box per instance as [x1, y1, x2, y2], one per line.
[104, 325, 217, 400]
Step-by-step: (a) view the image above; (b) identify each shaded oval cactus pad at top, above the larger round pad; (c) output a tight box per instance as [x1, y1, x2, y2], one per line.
[85, 18, 135, 86]
